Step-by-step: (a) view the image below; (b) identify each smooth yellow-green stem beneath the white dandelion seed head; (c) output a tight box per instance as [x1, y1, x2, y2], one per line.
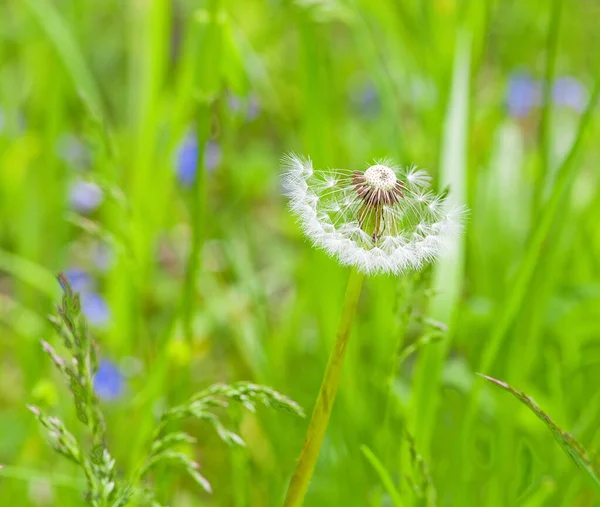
[284, 270, 364, 507]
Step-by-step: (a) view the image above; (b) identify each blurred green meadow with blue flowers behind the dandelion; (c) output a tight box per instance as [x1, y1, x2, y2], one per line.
[0, 0, 600, 507]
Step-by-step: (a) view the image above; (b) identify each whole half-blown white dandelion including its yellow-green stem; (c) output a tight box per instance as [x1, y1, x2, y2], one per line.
[283, 155, 465, 507]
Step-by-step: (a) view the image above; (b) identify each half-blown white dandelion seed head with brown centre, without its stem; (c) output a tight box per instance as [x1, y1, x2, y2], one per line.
[282, 154, 465, 274]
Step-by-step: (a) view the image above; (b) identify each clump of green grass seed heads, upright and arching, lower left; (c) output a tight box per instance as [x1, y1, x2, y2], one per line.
[28, 275, 304, 507]
